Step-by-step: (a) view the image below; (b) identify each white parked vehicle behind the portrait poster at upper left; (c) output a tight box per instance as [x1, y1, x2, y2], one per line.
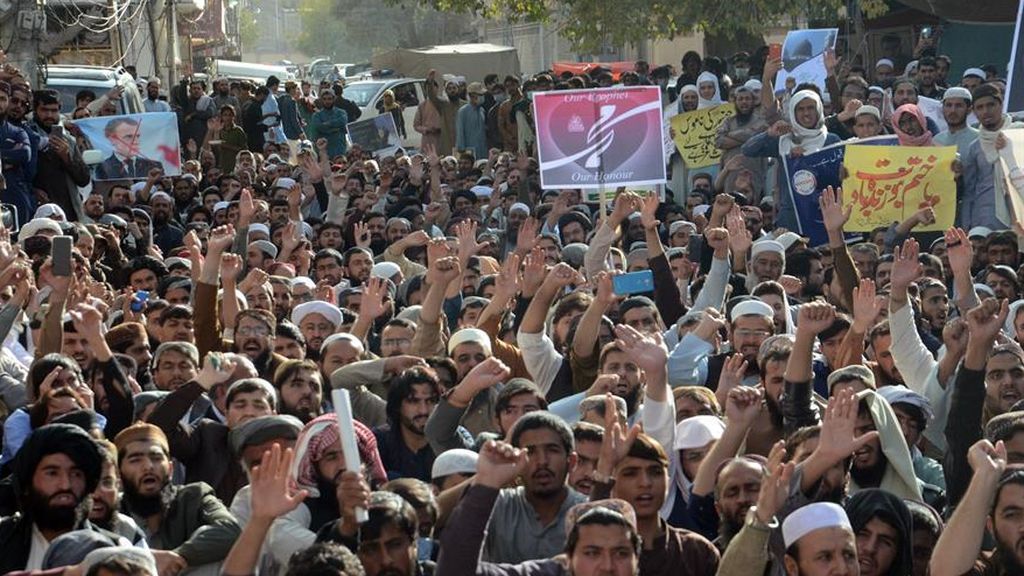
[43, 65, 145, 116]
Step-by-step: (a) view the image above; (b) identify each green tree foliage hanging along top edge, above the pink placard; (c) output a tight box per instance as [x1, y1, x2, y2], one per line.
[386, 0, 872, 53]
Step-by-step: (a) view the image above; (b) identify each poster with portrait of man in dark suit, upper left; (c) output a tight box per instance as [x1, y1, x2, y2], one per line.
[75, 112, 181, 180]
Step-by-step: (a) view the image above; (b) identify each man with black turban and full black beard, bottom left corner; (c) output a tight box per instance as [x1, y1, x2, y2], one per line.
[0, 424, 120, 574]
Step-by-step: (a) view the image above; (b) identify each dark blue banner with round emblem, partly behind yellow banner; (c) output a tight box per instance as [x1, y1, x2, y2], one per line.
[782, 135, 899, 246]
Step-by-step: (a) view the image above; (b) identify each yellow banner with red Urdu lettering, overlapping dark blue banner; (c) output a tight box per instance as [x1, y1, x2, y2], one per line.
[843, 146, 956, 232]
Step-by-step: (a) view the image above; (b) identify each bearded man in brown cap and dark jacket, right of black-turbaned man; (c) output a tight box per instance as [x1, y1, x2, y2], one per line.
[114, 422, 242, 574]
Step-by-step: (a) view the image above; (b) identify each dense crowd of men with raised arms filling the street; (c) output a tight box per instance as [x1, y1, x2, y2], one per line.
[0, 26, 1024, 576]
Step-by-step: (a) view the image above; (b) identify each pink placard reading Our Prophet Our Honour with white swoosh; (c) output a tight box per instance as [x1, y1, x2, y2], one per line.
[534, 86, 666, 189]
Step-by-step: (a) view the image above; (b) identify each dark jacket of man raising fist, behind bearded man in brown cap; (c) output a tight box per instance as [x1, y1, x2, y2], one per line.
[148, 381, 248, 502]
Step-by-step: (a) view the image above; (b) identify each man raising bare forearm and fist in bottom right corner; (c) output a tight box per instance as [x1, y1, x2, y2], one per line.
[931, 440, 1024, 576]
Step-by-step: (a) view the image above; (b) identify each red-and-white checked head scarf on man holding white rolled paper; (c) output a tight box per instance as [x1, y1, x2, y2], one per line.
[291, 412, 387, 498]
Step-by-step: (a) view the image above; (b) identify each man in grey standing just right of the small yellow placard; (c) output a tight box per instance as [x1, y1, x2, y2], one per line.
[715, 86, 768, 199]
